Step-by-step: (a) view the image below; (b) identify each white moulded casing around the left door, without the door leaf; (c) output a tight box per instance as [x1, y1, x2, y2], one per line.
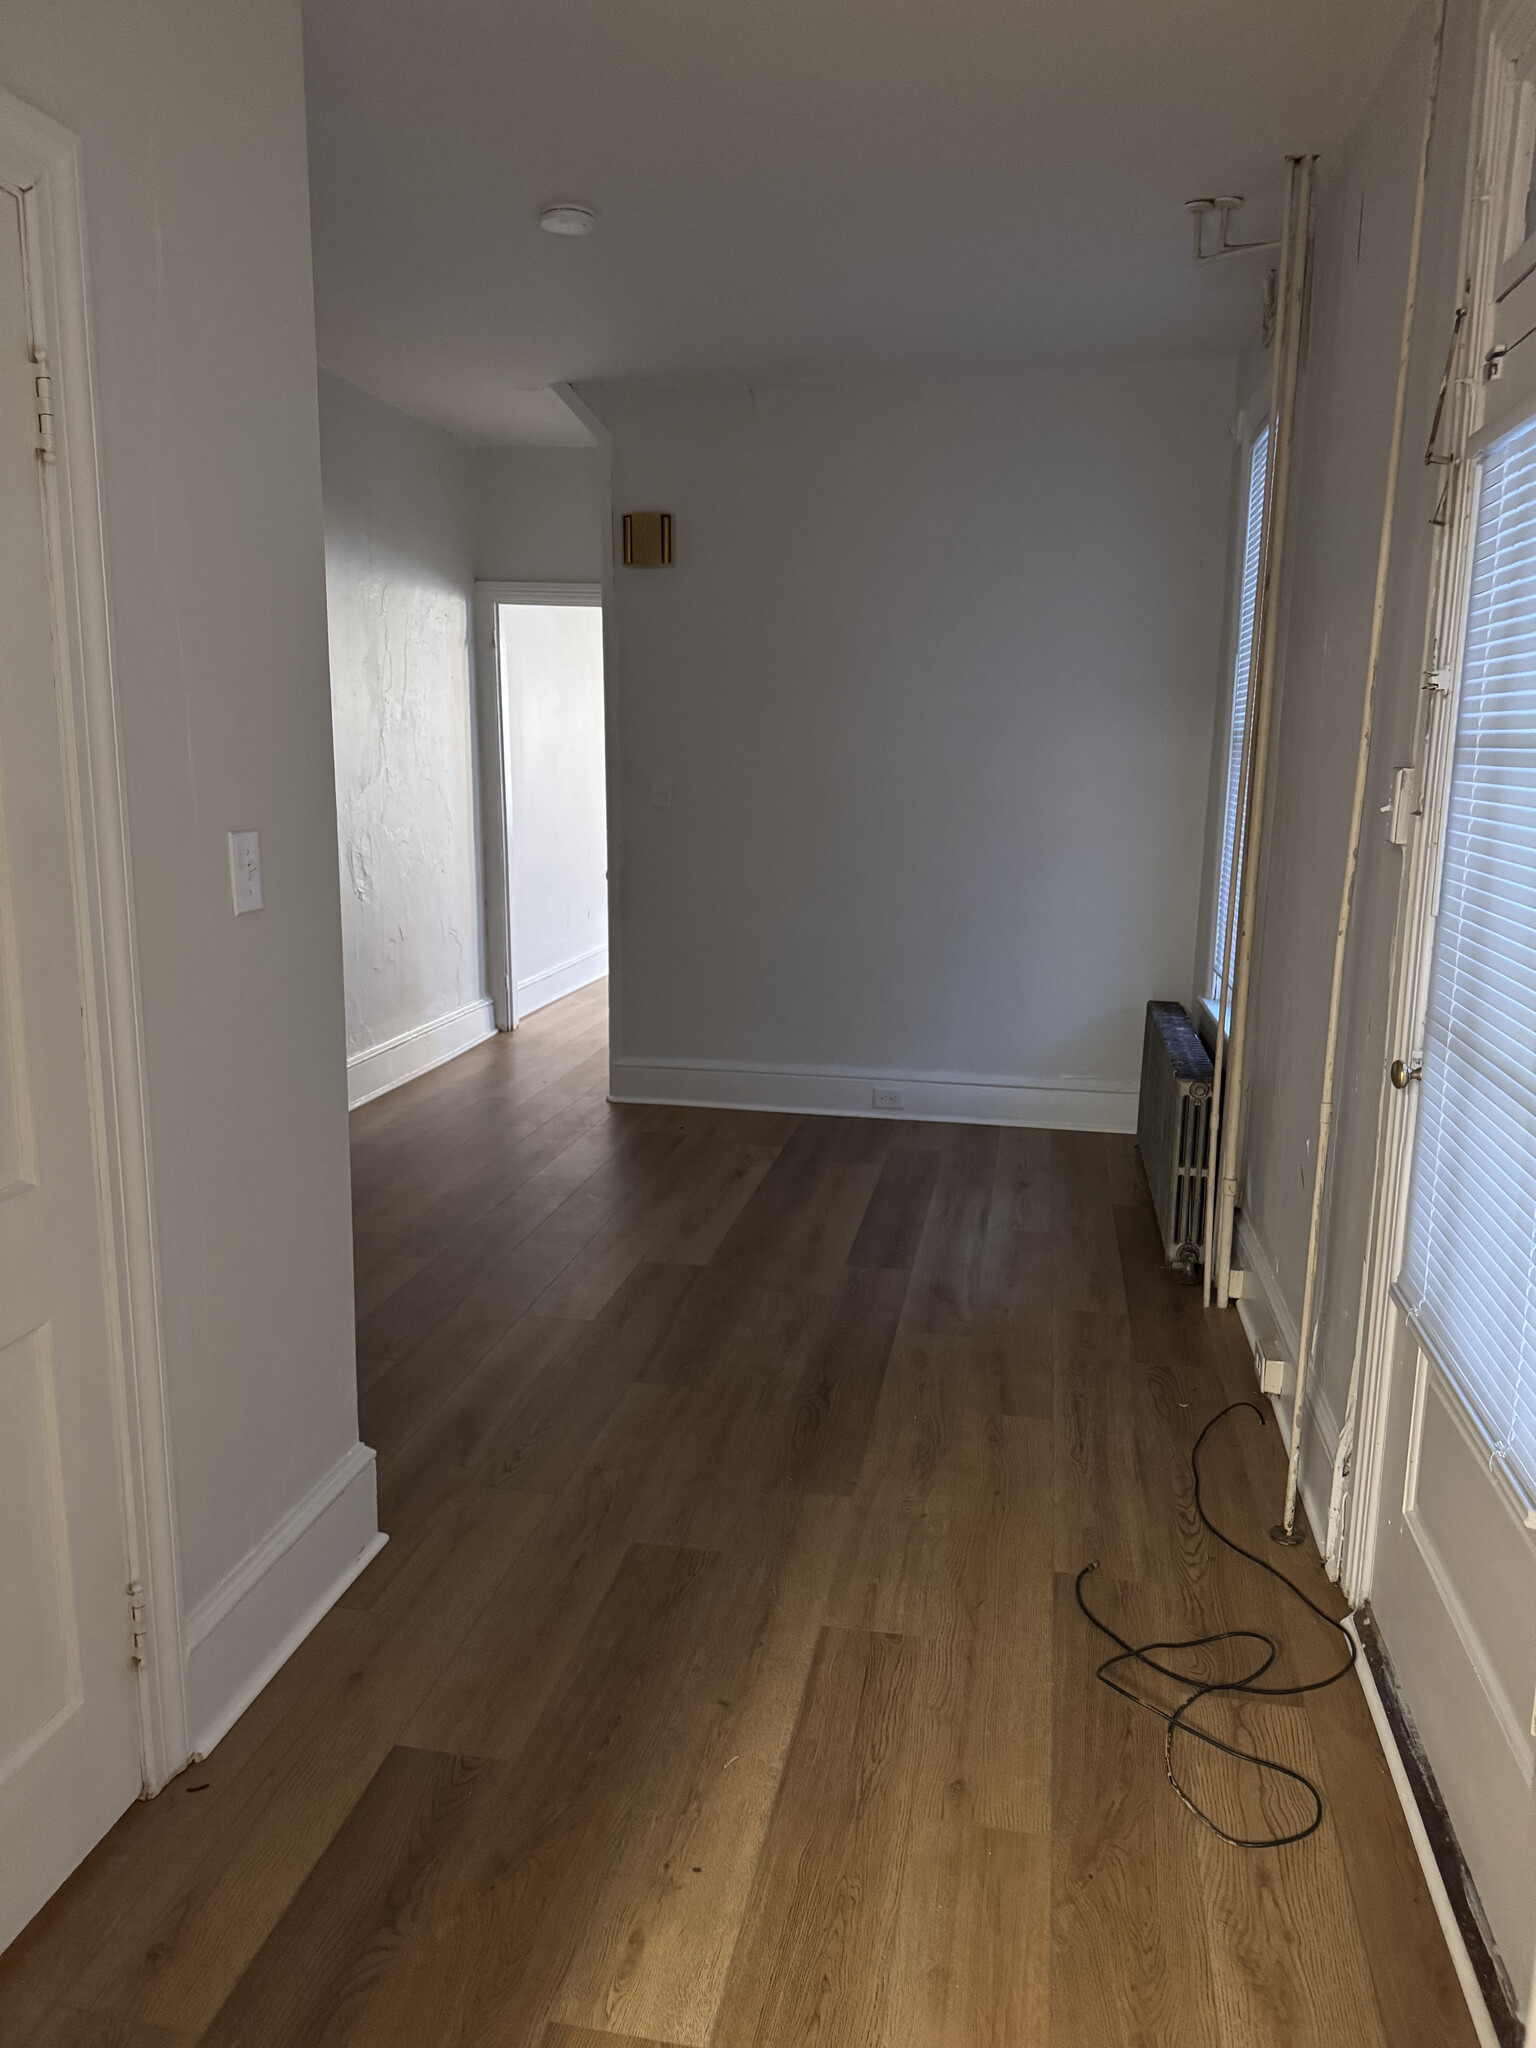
[0, 88, 188, 1796]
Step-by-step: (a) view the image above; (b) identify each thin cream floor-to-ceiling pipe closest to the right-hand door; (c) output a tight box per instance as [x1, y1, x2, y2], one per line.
[1276, 0, 1446, 1548]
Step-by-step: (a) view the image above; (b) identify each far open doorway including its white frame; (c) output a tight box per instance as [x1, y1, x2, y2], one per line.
[475, 584, 608, 1030]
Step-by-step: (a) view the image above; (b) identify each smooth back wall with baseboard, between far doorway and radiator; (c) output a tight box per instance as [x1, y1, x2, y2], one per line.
[582, 358, 1233, 1128]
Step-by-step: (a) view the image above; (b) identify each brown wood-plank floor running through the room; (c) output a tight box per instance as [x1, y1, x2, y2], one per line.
[0, 985, 1475, 2048]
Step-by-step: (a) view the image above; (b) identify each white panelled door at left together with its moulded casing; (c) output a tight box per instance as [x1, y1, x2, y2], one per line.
[0, 92, 186, 1946]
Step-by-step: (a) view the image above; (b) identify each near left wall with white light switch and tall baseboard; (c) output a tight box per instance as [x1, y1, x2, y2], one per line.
[0, 0, 375, 1739]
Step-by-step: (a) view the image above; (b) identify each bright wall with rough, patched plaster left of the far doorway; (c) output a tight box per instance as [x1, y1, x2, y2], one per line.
[319, 373, 494, 1102]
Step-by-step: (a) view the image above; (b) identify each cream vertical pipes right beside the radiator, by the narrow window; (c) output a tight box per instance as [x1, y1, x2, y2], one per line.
[1206, 156, 1317, 1309]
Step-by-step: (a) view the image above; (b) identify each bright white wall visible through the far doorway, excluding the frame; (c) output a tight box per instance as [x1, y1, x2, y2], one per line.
[496, 602, 608, 1024]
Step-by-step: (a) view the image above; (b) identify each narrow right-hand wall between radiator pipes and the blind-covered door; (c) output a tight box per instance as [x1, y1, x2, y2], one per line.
[1212, 6, 1477, 1509]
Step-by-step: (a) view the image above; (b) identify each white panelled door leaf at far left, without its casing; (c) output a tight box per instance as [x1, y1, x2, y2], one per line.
[0, 188, 141, 1946]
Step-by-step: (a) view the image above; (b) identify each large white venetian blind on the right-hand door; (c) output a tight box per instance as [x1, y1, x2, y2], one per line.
[1403, 403, 1536, 1501]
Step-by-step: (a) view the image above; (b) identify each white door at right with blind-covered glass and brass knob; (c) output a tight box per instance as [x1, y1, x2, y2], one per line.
[1370, 395, 1536, 2009]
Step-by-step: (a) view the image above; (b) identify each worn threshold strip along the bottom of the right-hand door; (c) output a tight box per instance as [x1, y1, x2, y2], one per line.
[1343, 1604, 1526, 2048]
